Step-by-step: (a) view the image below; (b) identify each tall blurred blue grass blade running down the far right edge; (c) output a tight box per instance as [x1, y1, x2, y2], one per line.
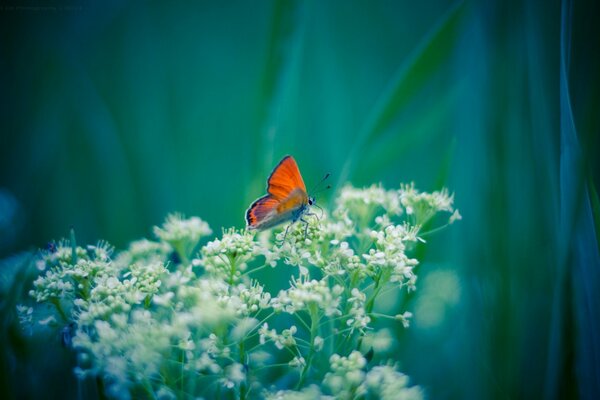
[546, 0, 600, 399]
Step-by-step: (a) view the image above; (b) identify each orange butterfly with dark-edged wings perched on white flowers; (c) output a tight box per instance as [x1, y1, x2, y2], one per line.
[246, 156, 326, 233]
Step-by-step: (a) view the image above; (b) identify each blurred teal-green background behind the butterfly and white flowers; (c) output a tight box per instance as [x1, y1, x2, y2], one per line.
[0, 0, 600, 399]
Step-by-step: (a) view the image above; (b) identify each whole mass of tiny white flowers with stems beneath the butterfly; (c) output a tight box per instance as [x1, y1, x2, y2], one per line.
[17, 185, 460, 399]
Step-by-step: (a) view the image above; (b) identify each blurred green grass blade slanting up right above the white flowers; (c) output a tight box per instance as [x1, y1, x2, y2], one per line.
[337, 2, 466, 187]
